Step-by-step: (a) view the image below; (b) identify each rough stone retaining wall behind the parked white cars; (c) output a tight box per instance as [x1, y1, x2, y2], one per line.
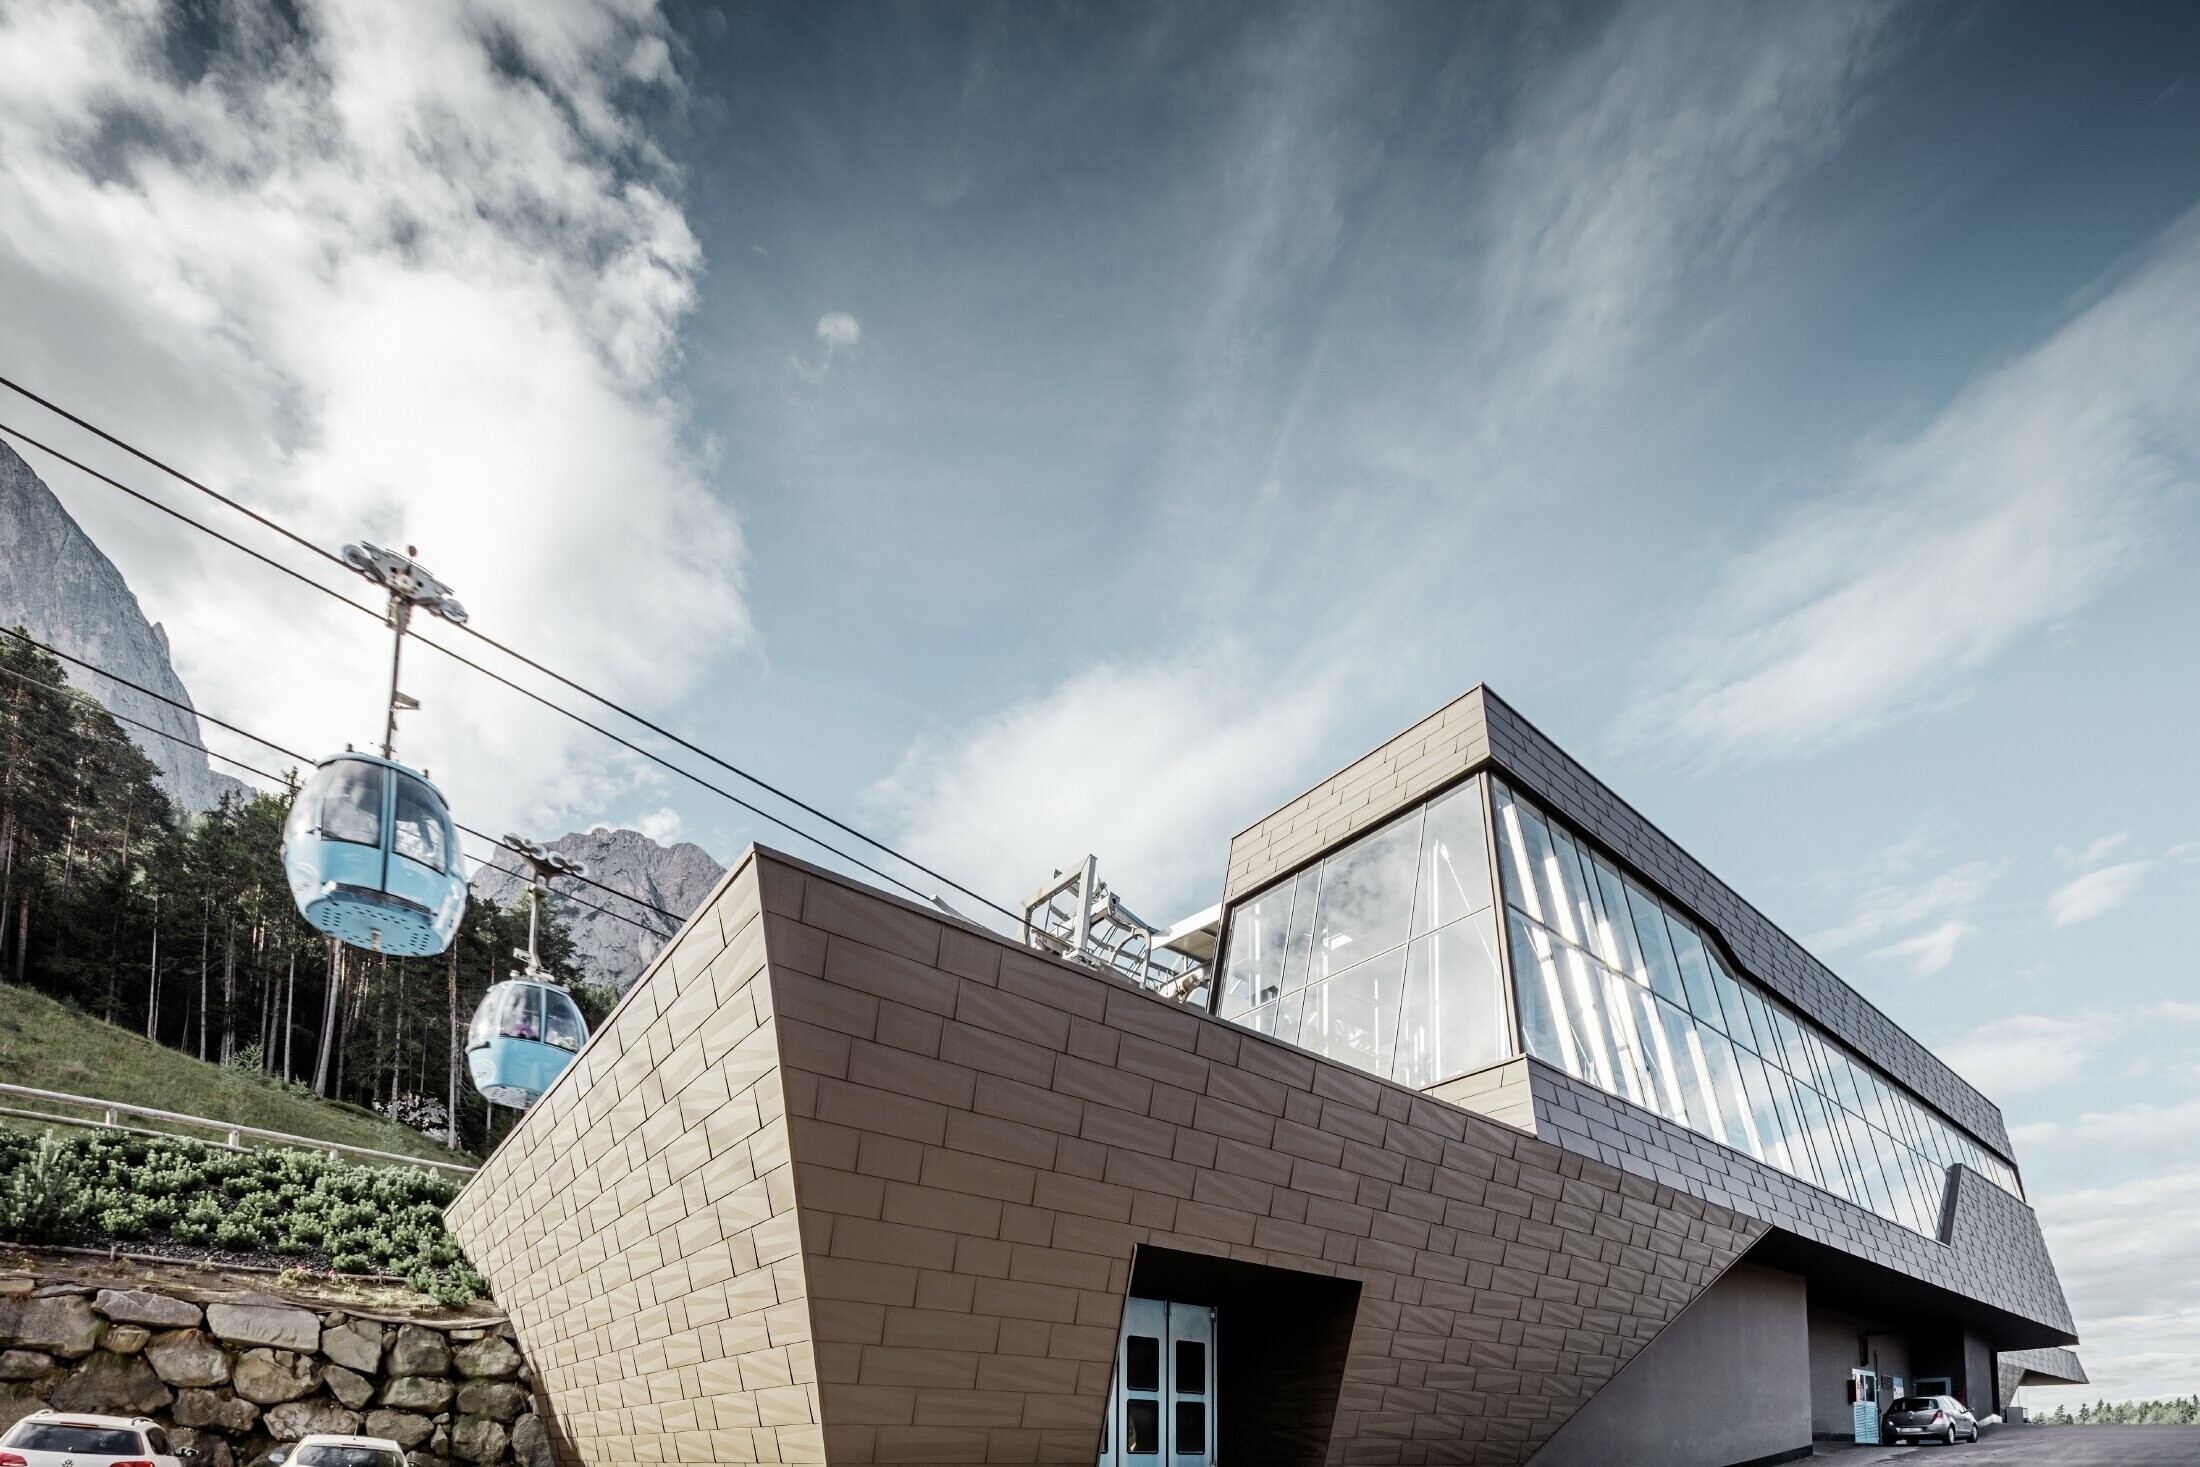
[0, 1278, 550, 1467]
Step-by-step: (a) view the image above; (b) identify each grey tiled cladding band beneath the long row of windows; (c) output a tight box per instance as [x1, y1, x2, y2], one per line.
[1527, 1060, 2075, 1335]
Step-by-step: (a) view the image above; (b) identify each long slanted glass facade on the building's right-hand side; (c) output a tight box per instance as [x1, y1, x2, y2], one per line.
[1492, 781, 2017, 1236]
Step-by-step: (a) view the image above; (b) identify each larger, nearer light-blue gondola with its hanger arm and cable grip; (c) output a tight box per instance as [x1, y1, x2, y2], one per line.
[282, 545, 466, 957]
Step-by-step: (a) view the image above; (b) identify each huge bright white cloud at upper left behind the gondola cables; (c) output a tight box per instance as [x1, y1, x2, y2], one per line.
[0, 0, 752, 829]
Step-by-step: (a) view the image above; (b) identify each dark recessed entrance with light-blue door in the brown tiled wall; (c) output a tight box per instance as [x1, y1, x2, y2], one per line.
[1100, 1247, 1360, 1467]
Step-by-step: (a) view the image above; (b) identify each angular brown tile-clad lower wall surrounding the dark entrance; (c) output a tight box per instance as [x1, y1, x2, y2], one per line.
[451, 851, 1762, 1467]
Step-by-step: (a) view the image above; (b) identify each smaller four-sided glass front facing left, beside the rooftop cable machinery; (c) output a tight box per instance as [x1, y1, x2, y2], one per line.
[1214, 779, 1518, 1089]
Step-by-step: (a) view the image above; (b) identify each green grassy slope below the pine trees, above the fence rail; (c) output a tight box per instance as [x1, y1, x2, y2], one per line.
[0, 983, 466, 1161]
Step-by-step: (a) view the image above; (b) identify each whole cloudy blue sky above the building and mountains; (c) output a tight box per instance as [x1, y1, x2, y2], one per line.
[0, 0, 2200, 1405]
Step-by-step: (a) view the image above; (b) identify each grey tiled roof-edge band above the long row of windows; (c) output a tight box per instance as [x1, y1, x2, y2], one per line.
[1478, 688, 2015, 1161]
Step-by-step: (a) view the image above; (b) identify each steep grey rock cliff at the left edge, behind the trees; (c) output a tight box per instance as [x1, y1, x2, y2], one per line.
[0, 442, 244, 812]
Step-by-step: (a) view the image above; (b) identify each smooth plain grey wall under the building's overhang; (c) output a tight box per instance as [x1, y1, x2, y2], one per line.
[1531, 1262, 1811, 1467]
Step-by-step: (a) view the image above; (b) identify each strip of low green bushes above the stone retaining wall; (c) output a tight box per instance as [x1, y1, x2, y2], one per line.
[0, 1130, 488, 1304]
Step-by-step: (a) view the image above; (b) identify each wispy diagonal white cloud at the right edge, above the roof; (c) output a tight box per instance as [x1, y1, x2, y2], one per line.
[1621, 213, 2200, 757]
